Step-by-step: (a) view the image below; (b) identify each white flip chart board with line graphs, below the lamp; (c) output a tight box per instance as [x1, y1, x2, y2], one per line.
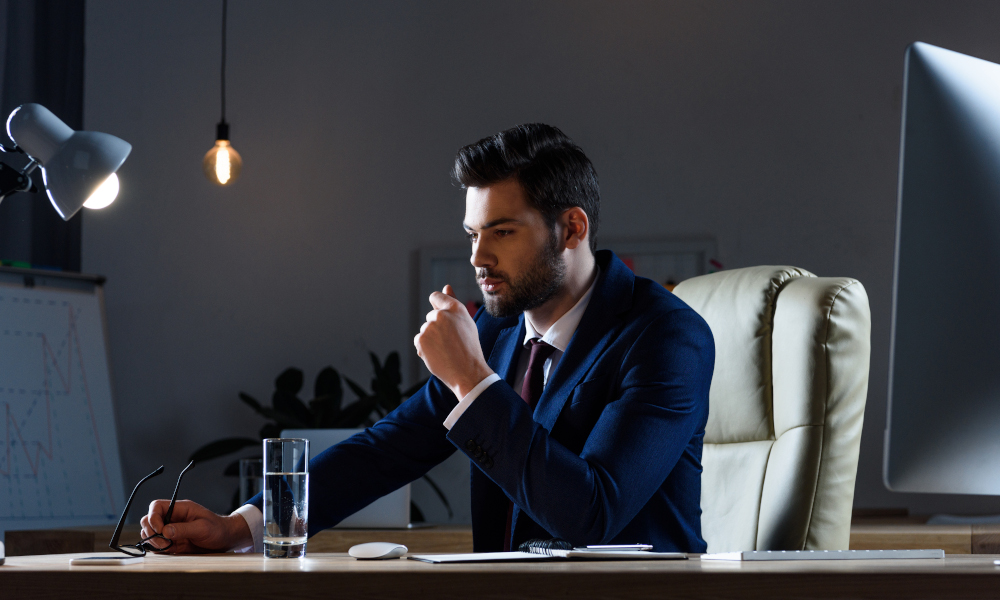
[0, 267, 125, 533]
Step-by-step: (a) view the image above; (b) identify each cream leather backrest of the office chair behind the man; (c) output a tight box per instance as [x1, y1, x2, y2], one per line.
[674, 267, 871, 552]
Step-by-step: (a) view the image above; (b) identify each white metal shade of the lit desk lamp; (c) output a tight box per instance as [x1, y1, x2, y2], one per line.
[7, 104, 132, 221]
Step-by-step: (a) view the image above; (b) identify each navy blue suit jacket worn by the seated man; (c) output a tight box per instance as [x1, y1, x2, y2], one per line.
[251, 251, 715, 552]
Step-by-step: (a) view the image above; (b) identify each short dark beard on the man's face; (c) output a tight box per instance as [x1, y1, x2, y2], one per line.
[476, 232, 566, 318]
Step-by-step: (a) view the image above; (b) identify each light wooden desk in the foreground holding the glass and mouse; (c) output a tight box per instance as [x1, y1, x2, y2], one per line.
[0, 553, 1000, 600]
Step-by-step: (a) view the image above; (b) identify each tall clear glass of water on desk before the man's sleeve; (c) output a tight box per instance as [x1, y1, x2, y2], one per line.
[264, 438, 309, 558]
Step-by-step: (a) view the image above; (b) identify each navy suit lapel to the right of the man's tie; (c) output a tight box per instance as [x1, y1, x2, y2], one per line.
[521, 250, 635, 431]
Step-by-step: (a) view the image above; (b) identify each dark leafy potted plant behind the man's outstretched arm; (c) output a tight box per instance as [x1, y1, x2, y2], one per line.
[189, 352, 453, 522]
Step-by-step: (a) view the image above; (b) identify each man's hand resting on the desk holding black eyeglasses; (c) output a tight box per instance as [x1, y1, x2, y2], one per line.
[141, 500, 253, 554]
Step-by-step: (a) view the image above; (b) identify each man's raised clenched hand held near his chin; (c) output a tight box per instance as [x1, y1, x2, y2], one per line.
[413, 285, 493, 400]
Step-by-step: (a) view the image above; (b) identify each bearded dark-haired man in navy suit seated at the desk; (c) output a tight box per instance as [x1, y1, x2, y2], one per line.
[142, 124, 715, 552]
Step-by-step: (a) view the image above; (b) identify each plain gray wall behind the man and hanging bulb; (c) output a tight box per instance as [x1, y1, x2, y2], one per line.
[83, 0, 1000, 520]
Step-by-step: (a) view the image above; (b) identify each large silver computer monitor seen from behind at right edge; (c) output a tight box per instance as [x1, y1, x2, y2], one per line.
[883, 42, 1000, 494]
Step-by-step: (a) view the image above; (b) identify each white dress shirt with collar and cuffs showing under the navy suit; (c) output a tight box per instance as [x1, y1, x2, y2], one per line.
[232, 277, 597, 552]
